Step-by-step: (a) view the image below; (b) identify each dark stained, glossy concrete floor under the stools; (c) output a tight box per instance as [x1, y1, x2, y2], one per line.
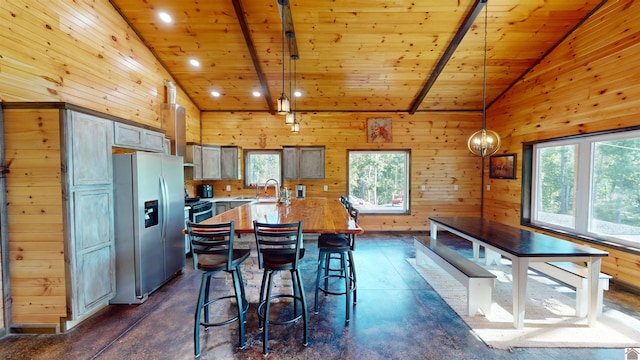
[0, 233, 640, 360]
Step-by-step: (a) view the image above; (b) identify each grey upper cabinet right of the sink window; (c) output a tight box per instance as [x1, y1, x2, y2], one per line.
[282, 146, 324, 180]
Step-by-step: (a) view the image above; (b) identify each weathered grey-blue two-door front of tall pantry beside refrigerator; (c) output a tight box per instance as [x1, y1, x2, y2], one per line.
[62, 110, 116, 328]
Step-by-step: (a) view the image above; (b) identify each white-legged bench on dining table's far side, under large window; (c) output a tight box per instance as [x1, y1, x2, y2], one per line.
[529, 262, 612, 317]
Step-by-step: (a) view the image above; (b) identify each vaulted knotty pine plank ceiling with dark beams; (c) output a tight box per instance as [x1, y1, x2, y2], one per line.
[111, 0, 606, 113]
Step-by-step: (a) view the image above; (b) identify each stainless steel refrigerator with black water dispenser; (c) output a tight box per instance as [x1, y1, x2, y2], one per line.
[111, 152, 185, 304]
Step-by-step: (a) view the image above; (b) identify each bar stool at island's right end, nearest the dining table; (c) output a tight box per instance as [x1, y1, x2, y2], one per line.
[314, 206, 360, 323]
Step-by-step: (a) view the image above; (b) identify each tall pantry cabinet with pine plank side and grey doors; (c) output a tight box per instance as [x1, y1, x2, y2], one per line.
[3, 103, 115, 332]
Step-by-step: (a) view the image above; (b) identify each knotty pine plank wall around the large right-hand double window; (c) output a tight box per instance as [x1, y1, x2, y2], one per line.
[484, 0, 640, 287]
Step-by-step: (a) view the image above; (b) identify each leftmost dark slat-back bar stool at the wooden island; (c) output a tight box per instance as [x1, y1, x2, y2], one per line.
[187, 221, 251, 358]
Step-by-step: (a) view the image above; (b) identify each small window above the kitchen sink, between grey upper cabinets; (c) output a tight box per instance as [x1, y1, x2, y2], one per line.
[244, 150, 282, 187]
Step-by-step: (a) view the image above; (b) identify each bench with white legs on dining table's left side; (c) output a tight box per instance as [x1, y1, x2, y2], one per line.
[413, 237, 496, 316]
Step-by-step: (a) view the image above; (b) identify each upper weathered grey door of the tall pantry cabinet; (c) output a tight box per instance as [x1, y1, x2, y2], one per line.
[67, 111, 113, 186]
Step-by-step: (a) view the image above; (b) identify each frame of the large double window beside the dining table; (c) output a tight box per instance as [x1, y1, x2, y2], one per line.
[520, 126, 640, 250]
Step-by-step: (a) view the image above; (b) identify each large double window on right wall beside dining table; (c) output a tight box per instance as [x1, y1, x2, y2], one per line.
[523, 130, 640, 247]
